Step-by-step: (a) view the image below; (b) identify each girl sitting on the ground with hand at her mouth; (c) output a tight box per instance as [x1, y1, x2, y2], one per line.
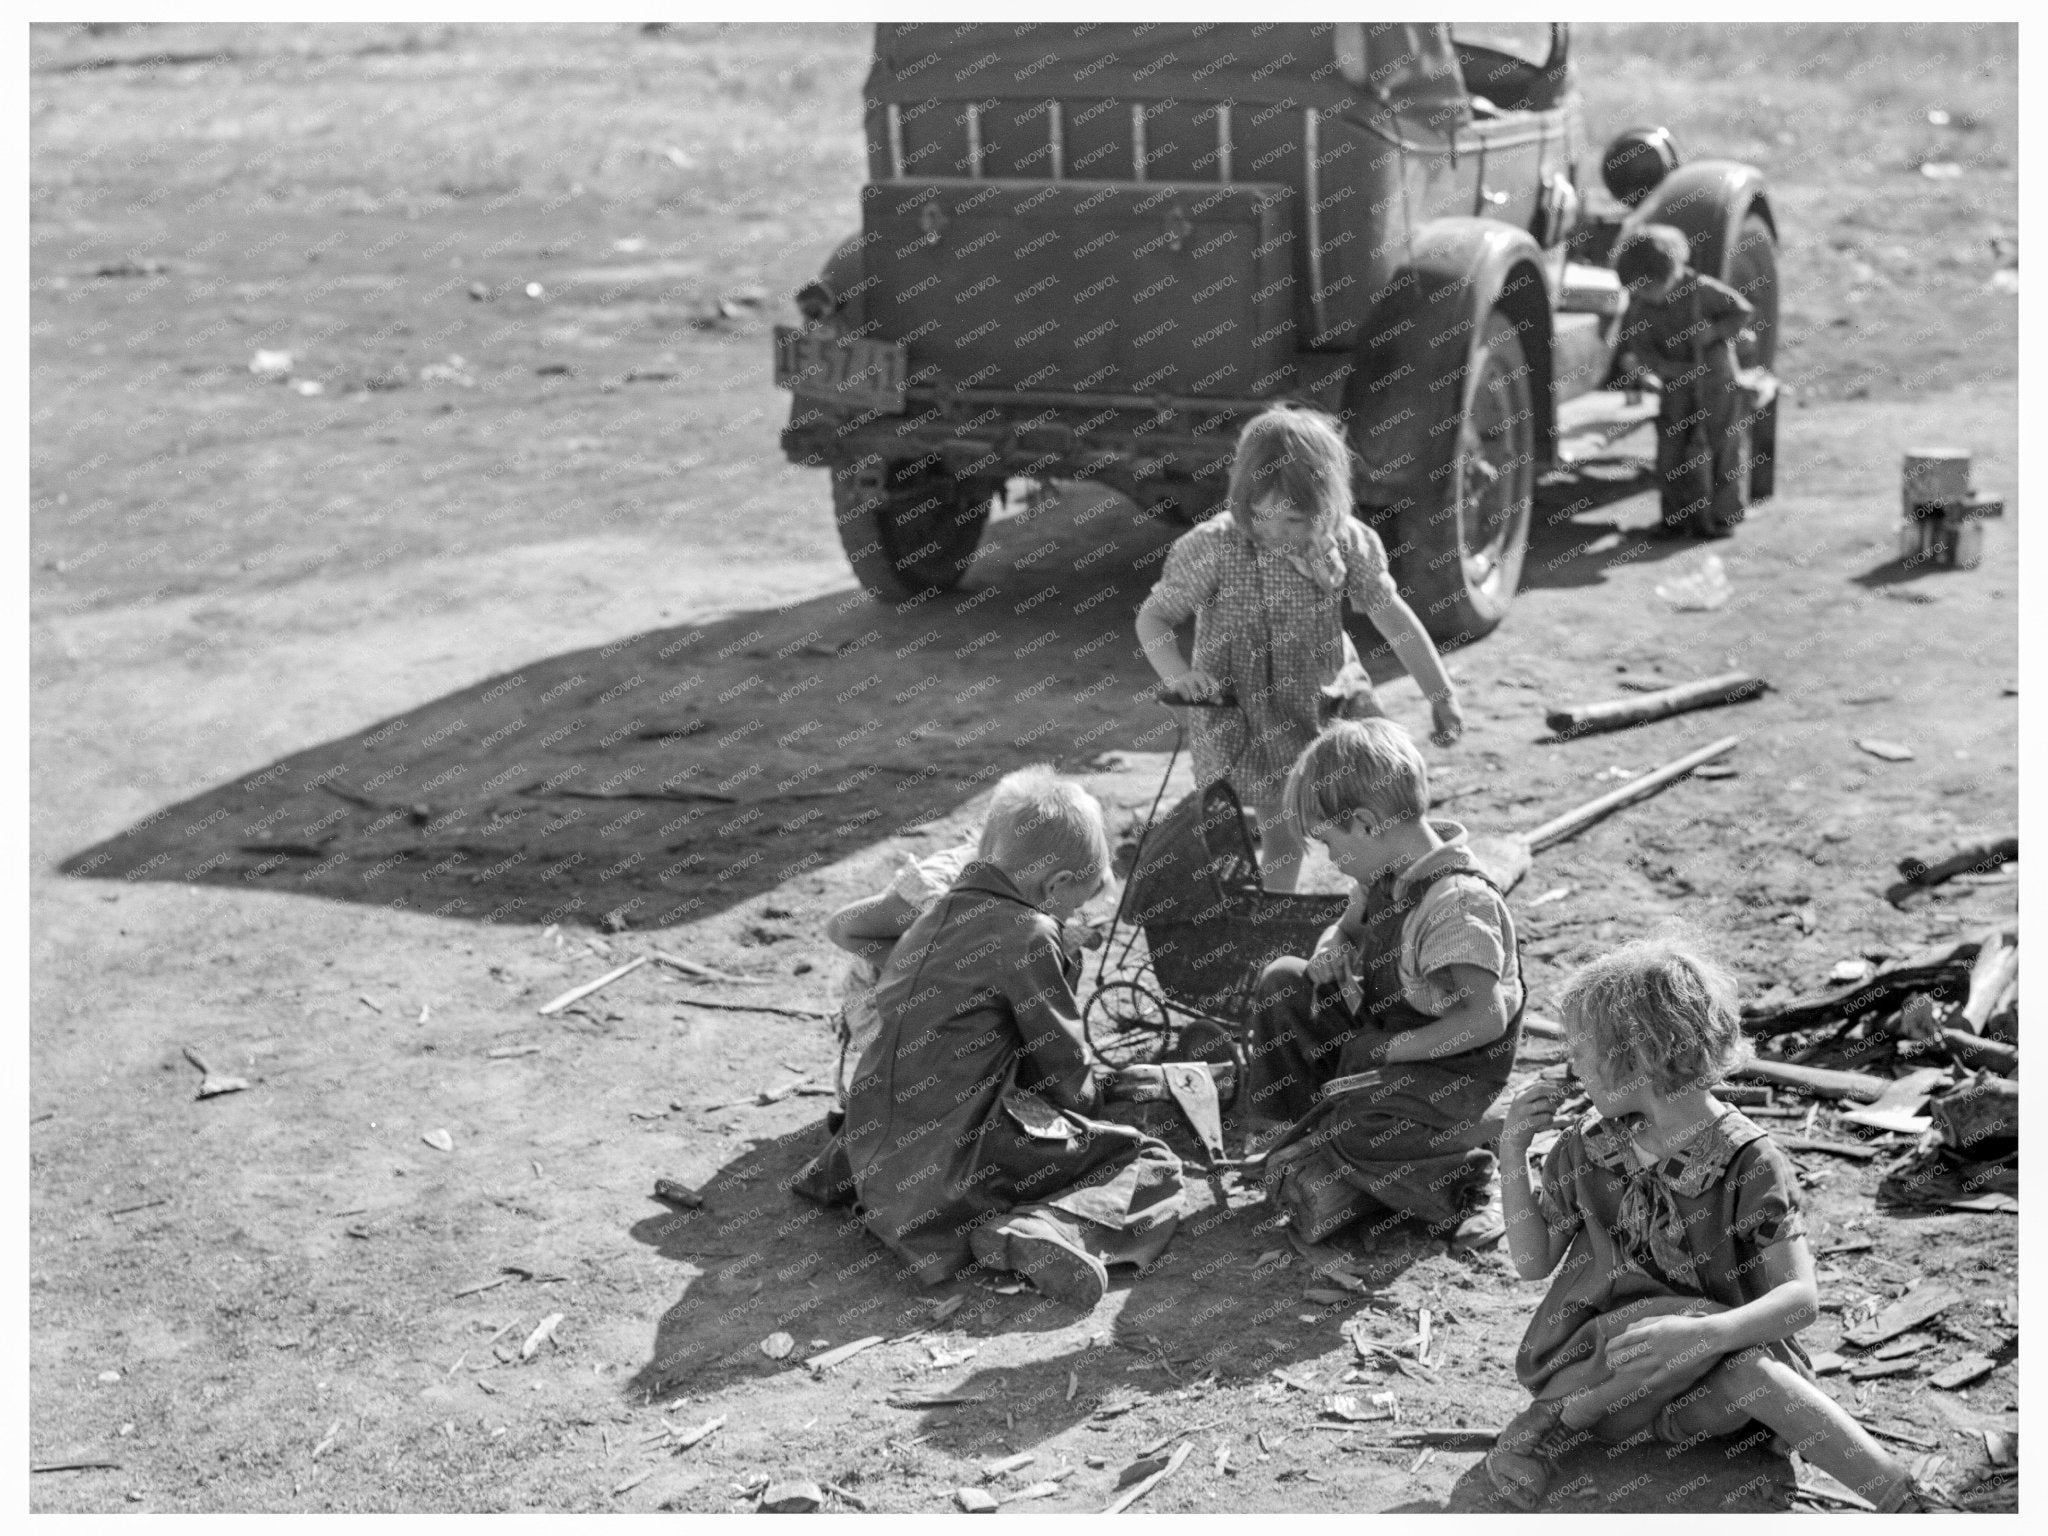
[1487, 940, 1933, 1511]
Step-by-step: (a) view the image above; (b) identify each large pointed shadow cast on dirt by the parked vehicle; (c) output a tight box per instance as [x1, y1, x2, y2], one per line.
[61, 494, 1174, 928]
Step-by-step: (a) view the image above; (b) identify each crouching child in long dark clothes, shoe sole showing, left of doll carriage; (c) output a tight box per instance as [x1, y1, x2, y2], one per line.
[793, 768, 1184, 1307]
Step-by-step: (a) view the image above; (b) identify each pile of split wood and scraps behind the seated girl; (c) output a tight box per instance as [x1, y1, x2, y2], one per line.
[1741, 926, 2019, 1212]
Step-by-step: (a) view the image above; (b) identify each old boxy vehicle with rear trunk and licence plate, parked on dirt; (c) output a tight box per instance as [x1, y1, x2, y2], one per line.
[774, 23, 1778, 645]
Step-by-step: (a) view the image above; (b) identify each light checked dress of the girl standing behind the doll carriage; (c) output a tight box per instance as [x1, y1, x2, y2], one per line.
[1145, 510, 1397, 821]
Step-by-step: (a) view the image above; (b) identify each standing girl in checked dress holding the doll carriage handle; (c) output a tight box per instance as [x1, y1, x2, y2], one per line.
[1137, 408, 1464, 891]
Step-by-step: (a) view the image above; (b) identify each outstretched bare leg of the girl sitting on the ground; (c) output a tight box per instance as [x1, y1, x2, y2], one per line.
[1654, 1350, 1913, 1509]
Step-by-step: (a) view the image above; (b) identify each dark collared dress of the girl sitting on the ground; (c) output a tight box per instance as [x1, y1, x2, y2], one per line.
[1516, 1110, 1812, 1399]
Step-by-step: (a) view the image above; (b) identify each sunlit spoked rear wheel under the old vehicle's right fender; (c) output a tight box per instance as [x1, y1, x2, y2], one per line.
[1384, 309, 1536, 649]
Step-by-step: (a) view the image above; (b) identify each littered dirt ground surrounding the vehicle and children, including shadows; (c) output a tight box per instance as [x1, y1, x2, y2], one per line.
[29, 29, 2019, 1511]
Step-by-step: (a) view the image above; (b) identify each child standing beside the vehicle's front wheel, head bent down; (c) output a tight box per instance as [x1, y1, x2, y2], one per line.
[1614, 223, 1755, 539]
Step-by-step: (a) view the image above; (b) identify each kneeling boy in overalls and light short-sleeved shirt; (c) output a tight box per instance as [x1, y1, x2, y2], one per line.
[1239, 719, 1524, 1249]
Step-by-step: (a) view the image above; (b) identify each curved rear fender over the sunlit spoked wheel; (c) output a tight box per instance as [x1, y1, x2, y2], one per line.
[1343, 217, 1556, 526]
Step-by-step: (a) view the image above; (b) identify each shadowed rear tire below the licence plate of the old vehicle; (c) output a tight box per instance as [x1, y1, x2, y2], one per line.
[831, 465, 1001, 602]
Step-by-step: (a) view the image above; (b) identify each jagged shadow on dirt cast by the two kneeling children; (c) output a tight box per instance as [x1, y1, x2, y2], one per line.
[625, 1106, 1442, 1454]
